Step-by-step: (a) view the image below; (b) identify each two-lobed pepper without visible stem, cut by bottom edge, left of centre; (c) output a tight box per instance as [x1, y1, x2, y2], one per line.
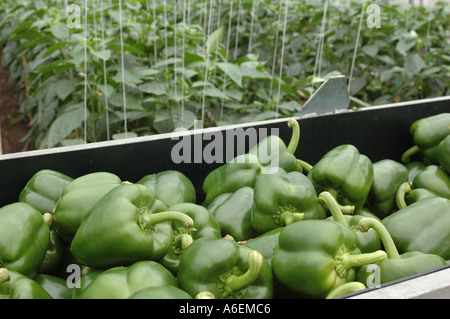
[79, 260, 178, 299]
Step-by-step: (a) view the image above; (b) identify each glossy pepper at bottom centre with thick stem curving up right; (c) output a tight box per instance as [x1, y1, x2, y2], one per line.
[177, 238, 273, 299]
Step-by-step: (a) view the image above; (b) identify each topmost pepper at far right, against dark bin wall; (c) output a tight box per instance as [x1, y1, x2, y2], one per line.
[401, 113, 450, 165]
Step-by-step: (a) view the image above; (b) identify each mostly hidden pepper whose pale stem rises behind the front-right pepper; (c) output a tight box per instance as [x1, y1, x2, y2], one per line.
[318, 192, 381, 253]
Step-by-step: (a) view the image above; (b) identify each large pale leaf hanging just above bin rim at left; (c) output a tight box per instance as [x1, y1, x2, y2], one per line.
[47, 107, 84, 148]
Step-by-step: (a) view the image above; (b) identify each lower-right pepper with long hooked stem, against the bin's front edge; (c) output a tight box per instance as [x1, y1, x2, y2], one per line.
[358, 218, 445, 285]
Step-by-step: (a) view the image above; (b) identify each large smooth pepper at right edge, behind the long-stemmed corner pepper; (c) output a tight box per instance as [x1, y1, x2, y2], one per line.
[382, 197, 450, 259]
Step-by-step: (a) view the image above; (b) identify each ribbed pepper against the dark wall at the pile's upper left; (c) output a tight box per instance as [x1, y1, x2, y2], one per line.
[19, 169, 73, 214]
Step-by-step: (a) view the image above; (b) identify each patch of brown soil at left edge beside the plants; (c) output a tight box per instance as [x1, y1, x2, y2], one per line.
[0, 69, 34, 154]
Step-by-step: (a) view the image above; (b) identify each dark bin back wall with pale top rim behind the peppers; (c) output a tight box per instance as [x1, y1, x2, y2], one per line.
[0, 97, 450, 207]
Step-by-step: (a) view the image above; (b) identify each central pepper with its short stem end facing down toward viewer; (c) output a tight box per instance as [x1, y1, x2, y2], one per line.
[251, 168, 326, 234]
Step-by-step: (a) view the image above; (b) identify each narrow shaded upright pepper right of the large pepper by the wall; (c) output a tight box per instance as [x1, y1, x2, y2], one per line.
[366, 159, 409, 218]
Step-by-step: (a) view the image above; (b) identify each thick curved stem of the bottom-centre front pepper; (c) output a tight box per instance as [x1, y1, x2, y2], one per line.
[224, 250, 264, 295]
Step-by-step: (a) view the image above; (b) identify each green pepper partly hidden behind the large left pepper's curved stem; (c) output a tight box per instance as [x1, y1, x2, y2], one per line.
[159, 203, 222, 275]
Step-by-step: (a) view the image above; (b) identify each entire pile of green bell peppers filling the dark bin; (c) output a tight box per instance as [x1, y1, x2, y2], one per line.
[0, 113, 450, 299]
